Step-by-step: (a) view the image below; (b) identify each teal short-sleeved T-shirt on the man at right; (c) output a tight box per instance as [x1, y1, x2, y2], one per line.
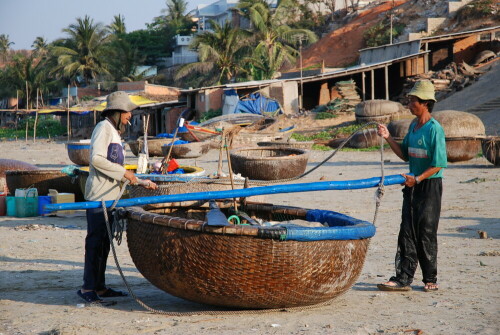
[401, 118, 447, 178]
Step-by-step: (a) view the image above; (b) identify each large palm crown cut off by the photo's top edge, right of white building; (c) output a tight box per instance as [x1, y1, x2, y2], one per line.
[238, 0, 317, 79]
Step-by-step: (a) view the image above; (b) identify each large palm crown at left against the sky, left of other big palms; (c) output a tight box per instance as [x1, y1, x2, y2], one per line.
[52, 16, 109, 84]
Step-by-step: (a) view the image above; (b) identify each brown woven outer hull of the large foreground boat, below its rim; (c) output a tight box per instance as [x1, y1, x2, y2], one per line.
[127, 207, 369, 309]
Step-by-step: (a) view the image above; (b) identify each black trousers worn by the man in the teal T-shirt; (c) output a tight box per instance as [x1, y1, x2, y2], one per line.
[391, 178, 443, 285]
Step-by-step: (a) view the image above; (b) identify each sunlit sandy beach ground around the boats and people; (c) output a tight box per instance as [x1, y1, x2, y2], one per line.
[0, 140, 500, 334]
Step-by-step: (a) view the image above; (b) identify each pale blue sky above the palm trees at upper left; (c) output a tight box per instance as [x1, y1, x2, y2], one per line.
[0, 0, 207, 50]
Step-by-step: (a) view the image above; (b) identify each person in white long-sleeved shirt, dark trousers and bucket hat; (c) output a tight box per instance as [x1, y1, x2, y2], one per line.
[77, 91, 157, 303]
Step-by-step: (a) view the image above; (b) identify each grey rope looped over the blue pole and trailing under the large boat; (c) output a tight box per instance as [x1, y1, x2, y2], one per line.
[102, 122, 384, 316]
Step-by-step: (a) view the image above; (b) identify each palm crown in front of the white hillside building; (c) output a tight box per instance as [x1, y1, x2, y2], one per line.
[175, 21, 249, 85]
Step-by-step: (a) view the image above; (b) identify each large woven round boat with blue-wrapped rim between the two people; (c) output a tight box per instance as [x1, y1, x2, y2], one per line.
[119, 202, 375, 309]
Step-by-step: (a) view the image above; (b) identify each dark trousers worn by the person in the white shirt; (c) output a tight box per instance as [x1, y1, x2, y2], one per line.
[82, 208, 113, 291]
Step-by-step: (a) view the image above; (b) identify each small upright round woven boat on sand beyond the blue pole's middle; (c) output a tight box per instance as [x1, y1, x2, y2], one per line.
[230, 147, 309, 180]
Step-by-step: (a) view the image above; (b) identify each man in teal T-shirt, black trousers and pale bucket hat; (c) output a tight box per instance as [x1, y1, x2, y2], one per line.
[377, 80, 447, 292]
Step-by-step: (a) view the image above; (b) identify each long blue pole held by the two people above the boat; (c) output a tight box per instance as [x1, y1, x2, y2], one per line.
[45, 174, 405, 212]
